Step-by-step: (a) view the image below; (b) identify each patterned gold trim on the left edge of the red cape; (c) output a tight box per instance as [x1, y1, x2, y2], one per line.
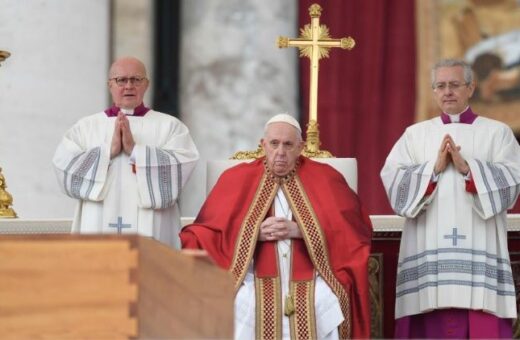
[229, 174, 278, 292]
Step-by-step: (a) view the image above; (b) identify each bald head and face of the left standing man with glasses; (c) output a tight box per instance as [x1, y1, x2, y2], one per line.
[108, 58, 148, 109]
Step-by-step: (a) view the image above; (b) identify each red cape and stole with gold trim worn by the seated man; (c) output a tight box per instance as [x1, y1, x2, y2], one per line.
[180, 157, 372, 338]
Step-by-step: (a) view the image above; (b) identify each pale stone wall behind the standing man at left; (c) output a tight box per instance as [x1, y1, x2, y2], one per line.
[0, 0, 110, 218]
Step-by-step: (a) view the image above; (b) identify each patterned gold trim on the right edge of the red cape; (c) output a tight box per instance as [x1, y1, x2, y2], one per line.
[282, 175, 352, 339]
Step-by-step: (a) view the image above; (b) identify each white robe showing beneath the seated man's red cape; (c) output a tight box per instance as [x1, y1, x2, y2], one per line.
[234, 189, 344, 340]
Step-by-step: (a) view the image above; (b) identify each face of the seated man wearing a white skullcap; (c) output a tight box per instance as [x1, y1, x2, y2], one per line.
[260, 122, 303, 176]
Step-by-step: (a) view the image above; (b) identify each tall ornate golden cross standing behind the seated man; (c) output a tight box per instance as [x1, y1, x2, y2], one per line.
[278, 4, 356, 157]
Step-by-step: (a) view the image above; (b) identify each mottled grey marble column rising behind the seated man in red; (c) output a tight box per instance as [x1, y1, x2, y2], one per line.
[180, 0, 299, 216]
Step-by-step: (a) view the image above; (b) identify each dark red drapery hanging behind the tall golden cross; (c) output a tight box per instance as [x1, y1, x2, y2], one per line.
[299, 0, 416, 214]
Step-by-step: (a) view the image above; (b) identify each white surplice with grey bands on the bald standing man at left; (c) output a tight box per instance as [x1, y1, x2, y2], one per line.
[53, 110, 199, 248]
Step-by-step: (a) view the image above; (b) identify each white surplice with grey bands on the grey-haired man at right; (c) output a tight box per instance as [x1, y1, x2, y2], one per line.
[381, 117, 520, 318]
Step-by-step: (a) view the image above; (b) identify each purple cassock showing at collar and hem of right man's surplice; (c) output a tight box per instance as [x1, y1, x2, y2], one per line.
[395, 107, 513, 339]
